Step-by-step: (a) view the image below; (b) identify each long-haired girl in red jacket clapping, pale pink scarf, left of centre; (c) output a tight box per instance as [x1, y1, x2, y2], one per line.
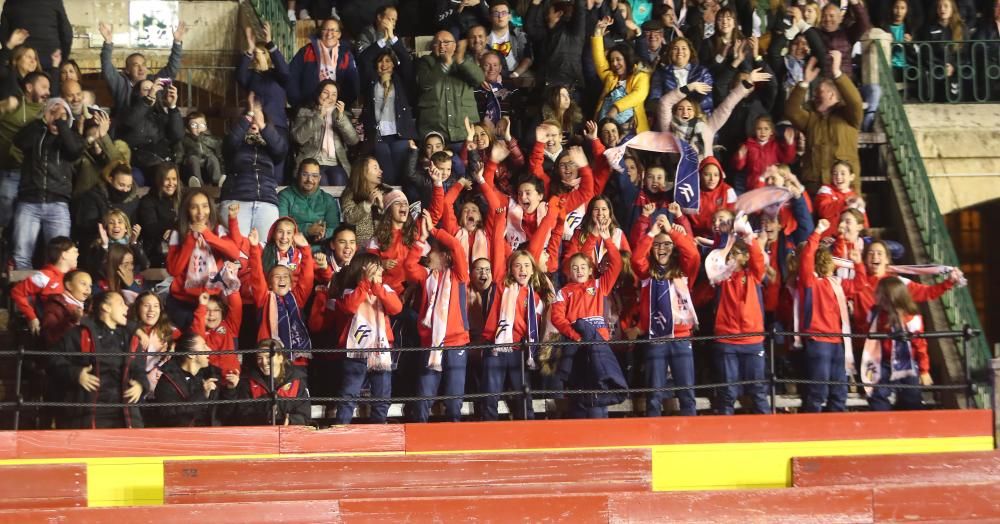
[167, 188, 240, 330]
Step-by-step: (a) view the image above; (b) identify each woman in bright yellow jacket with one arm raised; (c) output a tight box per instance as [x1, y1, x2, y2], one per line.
[590, 17, 649, 134]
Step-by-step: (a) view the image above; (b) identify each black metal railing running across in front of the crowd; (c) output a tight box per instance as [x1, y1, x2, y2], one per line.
[0, 326, 980, 430]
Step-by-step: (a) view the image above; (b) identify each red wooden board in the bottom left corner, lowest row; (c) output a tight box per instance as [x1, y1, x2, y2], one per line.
[0, 500, 341, 524]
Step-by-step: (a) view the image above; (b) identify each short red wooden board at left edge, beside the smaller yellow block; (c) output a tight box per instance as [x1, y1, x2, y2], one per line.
[0, 464, 87, 510]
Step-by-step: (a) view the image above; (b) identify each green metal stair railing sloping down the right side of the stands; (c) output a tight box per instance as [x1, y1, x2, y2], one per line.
[877, 46, 992, 402]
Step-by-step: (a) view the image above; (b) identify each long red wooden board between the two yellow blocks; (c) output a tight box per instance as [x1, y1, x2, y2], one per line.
[163, 449, 652, 504]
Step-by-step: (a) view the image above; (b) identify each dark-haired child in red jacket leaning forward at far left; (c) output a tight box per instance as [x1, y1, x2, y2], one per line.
[10, 237, 80, 335]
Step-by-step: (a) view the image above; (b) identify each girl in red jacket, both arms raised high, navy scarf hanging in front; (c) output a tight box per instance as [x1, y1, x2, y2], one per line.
[248, 230, 314, 365]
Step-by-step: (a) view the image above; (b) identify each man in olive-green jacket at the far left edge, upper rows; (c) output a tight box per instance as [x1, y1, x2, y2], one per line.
[0, 72, 49, 228]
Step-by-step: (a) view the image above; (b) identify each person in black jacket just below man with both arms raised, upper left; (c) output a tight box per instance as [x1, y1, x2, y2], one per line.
[118, 80, 184, 185]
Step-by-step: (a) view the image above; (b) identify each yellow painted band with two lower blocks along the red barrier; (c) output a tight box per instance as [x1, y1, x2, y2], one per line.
[0, 436, 993, 506]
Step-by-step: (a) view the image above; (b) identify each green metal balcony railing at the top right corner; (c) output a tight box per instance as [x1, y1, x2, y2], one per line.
[882, 40, 1000, 103]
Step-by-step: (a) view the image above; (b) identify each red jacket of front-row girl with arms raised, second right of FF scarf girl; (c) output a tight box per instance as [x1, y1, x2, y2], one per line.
[405, 229, 469, 347]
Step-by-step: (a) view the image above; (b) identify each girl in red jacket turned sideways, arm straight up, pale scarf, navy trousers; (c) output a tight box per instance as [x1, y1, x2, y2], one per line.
[795, 219, 864, 413]
